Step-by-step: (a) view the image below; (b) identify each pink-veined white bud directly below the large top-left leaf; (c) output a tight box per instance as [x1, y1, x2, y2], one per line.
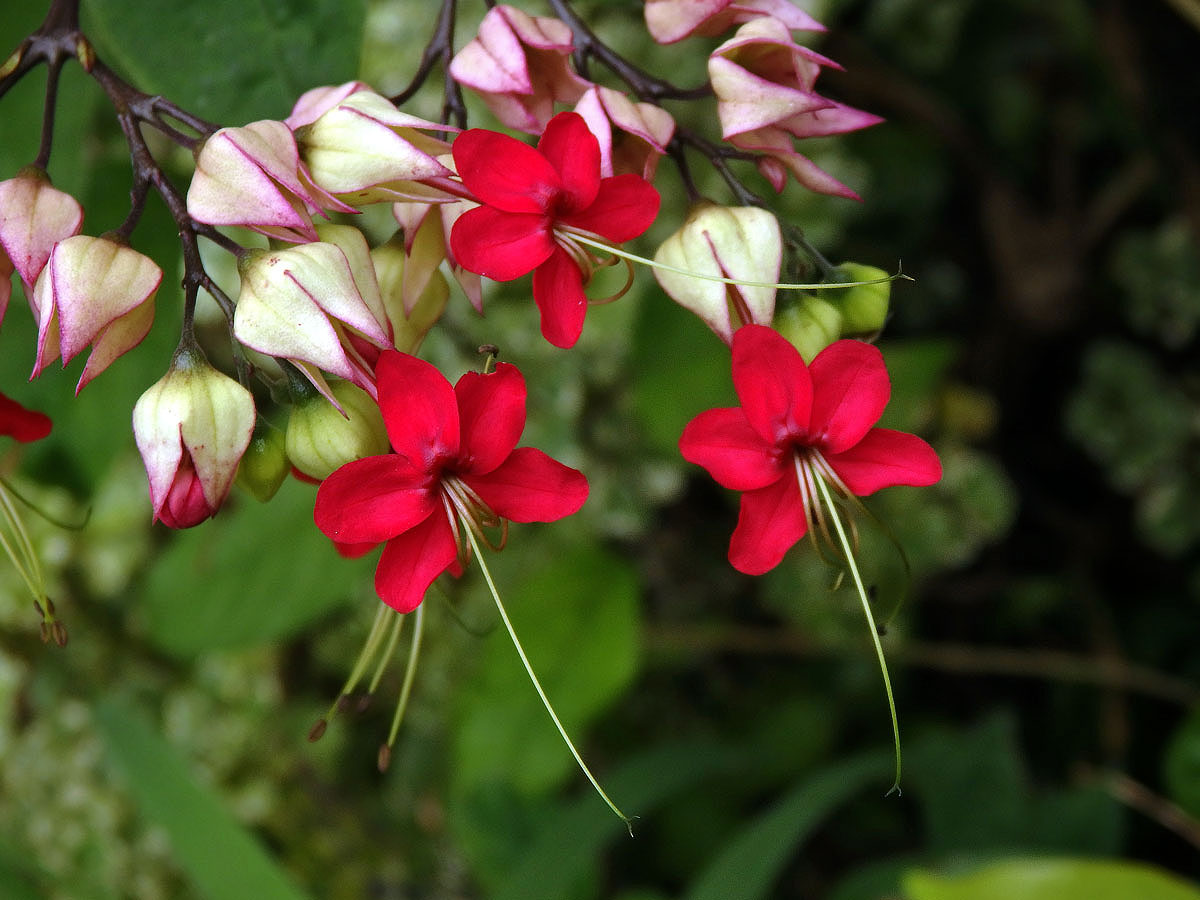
[187, 120, 353, 242]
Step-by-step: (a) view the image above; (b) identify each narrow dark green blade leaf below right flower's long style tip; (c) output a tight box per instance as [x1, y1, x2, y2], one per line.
[686, 754, 892, 900]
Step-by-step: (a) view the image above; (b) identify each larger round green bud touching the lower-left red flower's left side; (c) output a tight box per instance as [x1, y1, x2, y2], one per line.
[286, 382, 390, 481]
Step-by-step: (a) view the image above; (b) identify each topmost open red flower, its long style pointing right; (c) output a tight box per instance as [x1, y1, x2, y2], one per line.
[450, 113, 659, 347]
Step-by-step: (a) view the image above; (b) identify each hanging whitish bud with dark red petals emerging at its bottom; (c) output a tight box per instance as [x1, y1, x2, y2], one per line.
[133, 350, 254, 528]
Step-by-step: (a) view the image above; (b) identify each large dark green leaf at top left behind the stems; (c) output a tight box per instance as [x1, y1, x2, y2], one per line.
[84, 0, 366, 125]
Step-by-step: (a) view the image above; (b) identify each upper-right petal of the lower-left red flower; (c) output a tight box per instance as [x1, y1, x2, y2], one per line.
[454, 362, 526, 475]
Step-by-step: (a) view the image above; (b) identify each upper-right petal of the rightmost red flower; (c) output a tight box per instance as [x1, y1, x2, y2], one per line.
[809, 341, 892, 454]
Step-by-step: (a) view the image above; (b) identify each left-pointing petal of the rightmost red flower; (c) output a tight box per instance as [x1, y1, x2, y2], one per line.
[679, 407, 784, 491]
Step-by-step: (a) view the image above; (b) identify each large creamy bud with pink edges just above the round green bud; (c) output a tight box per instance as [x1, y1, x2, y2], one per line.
[233, 241, 391, 398]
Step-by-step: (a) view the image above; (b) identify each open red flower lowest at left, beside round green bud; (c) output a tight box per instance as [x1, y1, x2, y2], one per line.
[313, 350, 588, 612]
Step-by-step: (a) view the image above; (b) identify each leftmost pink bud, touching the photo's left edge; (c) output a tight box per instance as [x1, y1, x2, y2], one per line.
[0, 166, 83, 304]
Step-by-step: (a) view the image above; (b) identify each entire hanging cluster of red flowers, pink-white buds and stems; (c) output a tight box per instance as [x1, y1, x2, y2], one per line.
[0, 0, 940, 809]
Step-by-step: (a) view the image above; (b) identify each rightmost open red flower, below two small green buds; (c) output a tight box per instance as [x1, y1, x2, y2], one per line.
[679, 325, 942, 575]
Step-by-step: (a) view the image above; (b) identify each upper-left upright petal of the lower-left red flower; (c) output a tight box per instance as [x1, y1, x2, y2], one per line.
[376, 350, 458, 479]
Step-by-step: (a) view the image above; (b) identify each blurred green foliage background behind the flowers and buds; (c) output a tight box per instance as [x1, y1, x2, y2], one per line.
[0, 0, 1200, 900]
